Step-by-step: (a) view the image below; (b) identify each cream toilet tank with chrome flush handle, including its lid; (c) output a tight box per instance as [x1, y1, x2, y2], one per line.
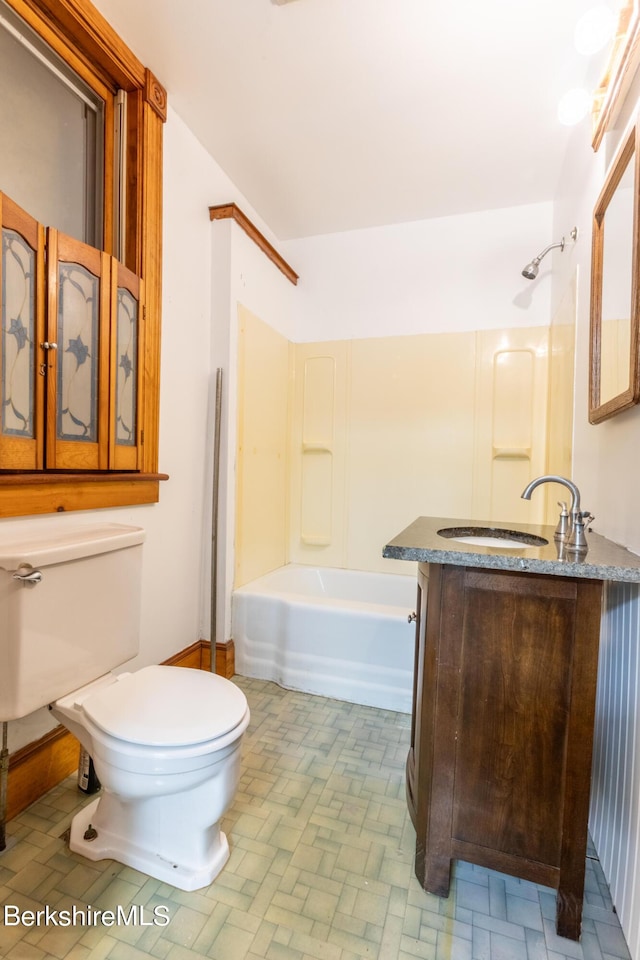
[0, 523, 144, 721]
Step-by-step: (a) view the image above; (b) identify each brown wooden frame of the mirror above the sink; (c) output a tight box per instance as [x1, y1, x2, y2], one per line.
[589, 118, 640, 423]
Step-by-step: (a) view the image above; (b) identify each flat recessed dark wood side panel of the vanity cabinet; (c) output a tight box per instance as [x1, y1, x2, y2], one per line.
[453, 577, 575, 866]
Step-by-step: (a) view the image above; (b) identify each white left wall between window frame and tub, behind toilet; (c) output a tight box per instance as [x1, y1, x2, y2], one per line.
[0, 103, 284, 751]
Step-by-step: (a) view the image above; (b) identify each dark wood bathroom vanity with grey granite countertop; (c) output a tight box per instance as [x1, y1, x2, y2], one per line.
[383, 517, 640, 940]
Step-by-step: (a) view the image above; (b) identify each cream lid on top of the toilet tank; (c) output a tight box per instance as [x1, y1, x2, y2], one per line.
[0, 523, 145, 570]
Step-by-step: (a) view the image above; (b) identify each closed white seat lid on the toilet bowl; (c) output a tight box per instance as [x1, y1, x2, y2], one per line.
[76, 666, 248, 747]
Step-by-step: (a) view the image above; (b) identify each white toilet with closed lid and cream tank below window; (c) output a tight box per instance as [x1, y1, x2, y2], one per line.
[0, 524, 249, 890]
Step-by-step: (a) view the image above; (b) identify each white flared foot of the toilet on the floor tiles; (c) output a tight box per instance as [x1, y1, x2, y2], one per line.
[69, 797, 229, 891]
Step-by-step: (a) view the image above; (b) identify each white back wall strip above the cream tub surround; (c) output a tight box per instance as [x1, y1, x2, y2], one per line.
[280, 203, 556, 342]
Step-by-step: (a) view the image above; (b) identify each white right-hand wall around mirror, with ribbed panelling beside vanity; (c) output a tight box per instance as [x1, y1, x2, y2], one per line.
[552, 84, 640, 960]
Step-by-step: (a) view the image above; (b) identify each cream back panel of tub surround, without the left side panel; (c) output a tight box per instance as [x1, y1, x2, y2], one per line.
[290, 327, 564, 572]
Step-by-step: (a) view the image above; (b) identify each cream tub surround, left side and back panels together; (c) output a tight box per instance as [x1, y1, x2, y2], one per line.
[235, 318, 573, 587]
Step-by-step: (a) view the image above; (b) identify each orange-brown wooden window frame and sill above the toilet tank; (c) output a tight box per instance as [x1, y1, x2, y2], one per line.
[0, 0, 167, 516]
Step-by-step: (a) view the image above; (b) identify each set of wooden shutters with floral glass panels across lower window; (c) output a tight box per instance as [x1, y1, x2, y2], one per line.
[0, 204, 145, 472]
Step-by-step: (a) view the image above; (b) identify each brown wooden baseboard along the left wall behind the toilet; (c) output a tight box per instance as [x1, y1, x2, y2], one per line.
[7, 640, 235, 820]
